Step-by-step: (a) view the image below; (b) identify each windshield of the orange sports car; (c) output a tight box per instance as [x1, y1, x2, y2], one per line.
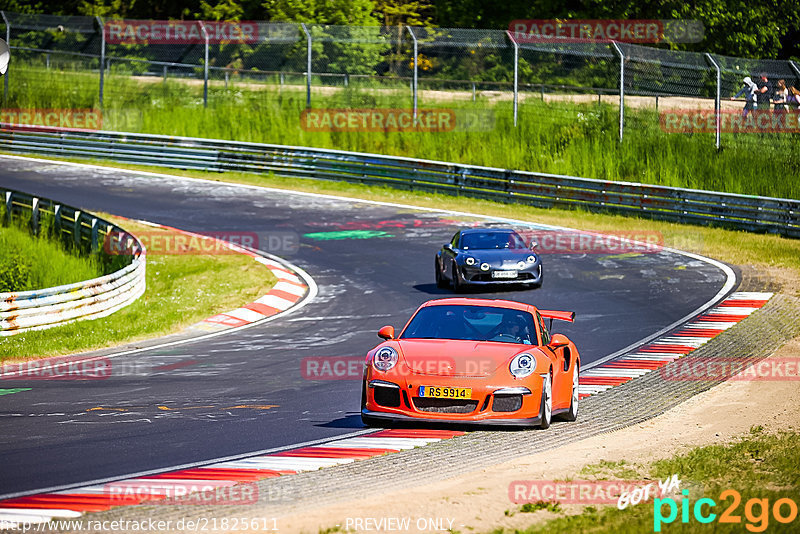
[400, 305, 537, 345]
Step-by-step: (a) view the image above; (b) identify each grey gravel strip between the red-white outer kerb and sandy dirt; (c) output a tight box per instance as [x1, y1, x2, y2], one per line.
[39, 269, 800, 532]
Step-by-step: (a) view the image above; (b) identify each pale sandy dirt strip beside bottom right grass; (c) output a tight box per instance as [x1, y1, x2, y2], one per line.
[278, 337, 800, 533]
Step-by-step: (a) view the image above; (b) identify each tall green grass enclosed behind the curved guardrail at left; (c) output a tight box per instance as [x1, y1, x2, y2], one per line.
[0, 225, 105, 293]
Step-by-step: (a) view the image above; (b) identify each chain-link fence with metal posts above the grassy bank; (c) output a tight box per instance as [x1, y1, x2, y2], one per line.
[0, 12, 800, 151]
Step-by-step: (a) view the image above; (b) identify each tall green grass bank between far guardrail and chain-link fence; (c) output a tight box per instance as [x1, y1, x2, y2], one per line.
[5, 64, 800, 198]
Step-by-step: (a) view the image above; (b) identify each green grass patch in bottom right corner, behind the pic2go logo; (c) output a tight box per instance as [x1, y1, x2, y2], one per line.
[494, 427, 800, 534]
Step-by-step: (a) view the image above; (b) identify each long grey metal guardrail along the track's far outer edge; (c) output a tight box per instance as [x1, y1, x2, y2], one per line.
[0, 124, 800, 237]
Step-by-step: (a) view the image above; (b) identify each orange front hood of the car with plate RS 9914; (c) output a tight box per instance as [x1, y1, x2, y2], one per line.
[398, 339, 533, 376]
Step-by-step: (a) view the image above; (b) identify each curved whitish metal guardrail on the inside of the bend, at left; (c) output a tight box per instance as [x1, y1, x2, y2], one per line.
[0, 188, 145, 336]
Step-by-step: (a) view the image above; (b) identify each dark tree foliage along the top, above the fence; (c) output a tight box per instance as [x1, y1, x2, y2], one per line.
[0, 0, 800, 58]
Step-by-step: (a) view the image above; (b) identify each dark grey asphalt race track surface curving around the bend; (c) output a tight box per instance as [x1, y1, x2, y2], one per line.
[0, 157, 726, 496]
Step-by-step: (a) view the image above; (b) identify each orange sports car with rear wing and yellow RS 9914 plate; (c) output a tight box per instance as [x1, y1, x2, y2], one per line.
[361, 298, 580, 428]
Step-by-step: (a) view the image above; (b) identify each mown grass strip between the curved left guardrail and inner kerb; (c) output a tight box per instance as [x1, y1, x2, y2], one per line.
[0, 216, 275, 360]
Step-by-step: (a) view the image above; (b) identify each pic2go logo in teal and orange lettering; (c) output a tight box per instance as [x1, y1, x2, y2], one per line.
[653, 489, 797, 532]
